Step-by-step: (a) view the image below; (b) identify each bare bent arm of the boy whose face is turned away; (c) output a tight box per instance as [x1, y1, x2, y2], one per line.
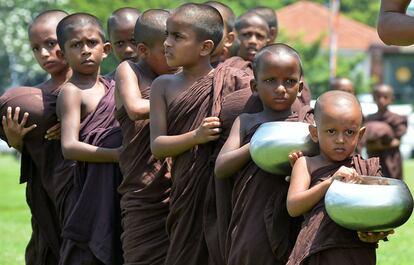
[115, 61, 150, 121]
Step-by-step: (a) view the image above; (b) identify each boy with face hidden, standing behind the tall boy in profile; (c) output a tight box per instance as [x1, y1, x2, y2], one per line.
[115, 9, 175, 265]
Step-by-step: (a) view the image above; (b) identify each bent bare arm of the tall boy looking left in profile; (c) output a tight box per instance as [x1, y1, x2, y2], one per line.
[150, 79, 221, 158]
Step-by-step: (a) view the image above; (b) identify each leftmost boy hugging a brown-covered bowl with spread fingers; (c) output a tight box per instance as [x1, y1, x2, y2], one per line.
[0, 10, 71, 265]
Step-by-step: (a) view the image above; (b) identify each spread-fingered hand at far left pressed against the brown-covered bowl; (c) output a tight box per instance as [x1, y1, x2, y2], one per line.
[2, 107, 37, 150]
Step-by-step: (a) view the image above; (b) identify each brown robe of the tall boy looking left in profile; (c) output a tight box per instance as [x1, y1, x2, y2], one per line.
[166, 62, 251, 265]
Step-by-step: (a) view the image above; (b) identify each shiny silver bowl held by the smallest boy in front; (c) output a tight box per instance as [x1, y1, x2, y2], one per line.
[325, 176, 413, 231]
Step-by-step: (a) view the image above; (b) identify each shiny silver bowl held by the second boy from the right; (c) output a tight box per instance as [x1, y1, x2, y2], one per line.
[250, 121, 318, 175]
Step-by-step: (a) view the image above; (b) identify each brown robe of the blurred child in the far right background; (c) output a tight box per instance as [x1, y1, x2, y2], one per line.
[365, 110, 407, 179]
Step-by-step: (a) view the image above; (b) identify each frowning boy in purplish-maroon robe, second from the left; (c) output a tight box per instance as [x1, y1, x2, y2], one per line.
[57, 13, 122, 264]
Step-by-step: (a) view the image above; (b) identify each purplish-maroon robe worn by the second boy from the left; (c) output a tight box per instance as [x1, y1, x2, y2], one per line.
[60, 78, 122, 265]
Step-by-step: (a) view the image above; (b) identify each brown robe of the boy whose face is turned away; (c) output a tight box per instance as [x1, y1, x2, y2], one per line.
[116, 64, 171, 265]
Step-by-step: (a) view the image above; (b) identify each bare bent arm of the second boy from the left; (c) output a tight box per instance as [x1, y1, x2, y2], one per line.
[56, 84, 119, 162]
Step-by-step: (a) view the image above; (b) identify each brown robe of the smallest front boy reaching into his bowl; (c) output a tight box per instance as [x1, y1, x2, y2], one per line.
[287, 155, 381, 265]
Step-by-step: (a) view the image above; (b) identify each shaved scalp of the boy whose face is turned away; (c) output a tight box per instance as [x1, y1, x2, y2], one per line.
[134, 9, 170, 47]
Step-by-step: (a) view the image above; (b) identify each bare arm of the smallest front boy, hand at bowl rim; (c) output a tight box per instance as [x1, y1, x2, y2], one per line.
[286, 157, 358, 216]
